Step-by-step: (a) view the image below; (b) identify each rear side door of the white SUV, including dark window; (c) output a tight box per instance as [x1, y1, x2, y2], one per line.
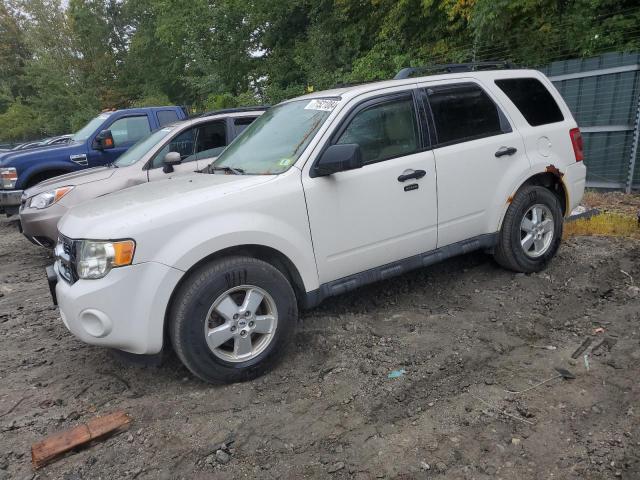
[419, 79, 529, 247]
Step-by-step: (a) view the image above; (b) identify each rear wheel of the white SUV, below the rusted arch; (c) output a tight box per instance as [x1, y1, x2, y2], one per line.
[495, 186, 563, 273]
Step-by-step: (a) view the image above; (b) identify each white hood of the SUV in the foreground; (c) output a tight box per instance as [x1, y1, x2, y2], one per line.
[58, 173, 276, 239]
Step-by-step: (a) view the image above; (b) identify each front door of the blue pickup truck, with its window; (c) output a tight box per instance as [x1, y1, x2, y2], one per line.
[88, 114, 155, 167]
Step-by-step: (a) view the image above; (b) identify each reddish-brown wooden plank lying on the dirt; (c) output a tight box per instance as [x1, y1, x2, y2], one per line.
[31, 410, 131, 469]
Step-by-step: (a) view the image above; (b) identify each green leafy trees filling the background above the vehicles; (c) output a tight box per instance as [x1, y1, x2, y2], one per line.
[0, 0, 640, 141]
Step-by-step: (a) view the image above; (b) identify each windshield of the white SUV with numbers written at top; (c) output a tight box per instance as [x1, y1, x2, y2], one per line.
[211, 98, 338, 175]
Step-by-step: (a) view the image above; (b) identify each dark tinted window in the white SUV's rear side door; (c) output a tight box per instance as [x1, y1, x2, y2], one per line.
[426, 83, 511, 146]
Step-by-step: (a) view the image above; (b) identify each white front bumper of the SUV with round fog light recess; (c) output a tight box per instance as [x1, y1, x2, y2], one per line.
[55, 262, 183, 355]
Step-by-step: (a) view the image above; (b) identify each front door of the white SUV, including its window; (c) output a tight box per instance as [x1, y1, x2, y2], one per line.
[303, 90, 438, 283]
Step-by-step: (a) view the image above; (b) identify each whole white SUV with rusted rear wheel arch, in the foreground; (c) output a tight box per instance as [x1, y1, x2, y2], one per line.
[48, 67, 586, 382]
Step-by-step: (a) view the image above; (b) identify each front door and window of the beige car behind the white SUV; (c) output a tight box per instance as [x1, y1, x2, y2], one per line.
[147, 120, 227, 182]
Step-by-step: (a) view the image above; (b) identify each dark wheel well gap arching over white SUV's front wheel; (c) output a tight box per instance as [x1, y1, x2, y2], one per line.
[164, 245, 306, 346]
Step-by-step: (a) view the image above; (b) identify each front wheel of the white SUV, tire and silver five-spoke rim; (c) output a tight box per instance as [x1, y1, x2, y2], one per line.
[169, 257, 298, 383]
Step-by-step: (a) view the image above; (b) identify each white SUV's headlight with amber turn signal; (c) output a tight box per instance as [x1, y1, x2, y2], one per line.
[76, 240, 136, 279]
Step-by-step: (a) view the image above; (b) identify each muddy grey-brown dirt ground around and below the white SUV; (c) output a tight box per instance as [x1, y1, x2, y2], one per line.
[0, 220, 640, 480]
